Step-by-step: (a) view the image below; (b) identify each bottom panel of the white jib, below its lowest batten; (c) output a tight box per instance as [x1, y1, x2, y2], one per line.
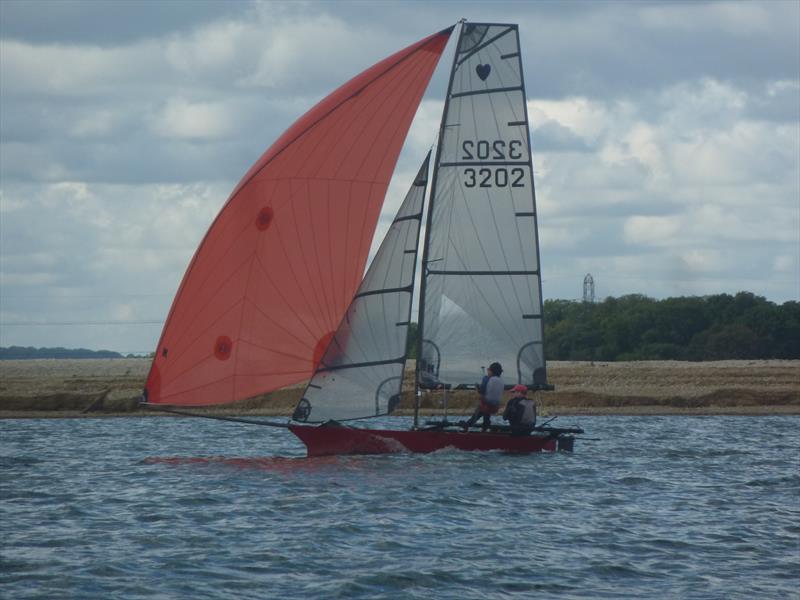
[303, 363, 403, 423]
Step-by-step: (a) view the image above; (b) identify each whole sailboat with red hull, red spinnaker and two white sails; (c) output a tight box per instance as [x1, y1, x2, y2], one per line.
[143, 21, 582, 456]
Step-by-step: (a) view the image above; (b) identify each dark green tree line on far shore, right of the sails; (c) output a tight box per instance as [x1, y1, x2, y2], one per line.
[408, 292, 800, 361]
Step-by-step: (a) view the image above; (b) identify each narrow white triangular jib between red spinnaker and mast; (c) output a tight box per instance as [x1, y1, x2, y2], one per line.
[293, 153, 430, 422]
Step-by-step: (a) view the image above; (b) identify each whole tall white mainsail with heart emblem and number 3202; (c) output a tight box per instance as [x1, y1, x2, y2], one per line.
[419, 24, 547, 387]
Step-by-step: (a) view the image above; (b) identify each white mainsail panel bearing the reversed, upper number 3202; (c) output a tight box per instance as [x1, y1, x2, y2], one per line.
[441, 89, 530, 165]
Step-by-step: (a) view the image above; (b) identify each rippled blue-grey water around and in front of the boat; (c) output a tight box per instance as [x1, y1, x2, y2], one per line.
[0, 417, 800, 600]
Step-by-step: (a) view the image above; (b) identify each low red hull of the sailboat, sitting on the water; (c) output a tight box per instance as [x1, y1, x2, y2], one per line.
[289, 425, 557, 456]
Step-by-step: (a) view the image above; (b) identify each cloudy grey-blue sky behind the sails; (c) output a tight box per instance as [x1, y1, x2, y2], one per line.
[0, 0, 800, 353]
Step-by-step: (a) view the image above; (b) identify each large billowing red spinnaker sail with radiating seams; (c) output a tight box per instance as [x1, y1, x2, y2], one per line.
[146, 28, 452, 406]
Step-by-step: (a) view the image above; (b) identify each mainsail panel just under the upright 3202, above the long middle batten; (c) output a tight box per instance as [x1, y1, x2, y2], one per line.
[428, 167, 539, 271]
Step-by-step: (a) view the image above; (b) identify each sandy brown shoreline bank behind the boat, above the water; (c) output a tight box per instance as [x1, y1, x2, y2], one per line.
[0, 359, 800, 418]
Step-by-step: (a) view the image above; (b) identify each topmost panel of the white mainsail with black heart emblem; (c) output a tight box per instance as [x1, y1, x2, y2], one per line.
[451, 25, 522, 95]
